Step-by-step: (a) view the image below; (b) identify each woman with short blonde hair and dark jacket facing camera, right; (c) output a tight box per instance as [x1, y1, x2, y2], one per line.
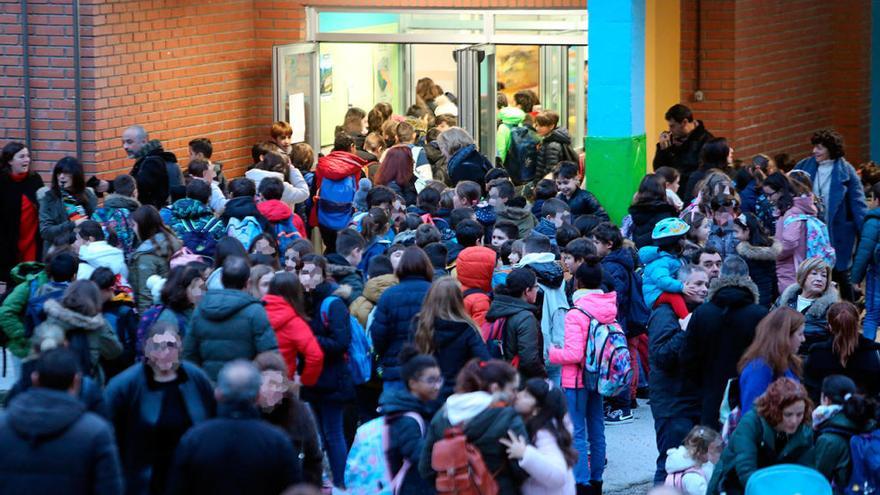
[773, 257, 839, 355]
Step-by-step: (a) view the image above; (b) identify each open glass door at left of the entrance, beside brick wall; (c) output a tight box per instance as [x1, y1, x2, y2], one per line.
[272, 43, 324, 153]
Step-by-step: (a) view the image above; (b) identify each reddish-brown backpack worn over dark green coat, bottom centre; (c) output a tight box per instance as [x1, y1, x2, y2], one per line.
[431, 426, 498, 495]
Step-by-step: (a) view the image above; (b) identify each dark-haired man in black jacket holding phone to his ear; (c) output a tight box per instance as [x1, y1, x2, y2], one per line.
[654, 103, 714, 204]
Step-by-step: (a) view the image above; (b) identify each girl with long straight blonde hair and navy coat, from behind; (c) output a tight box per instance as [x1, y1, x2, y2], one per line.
[413, 277, 489, 400]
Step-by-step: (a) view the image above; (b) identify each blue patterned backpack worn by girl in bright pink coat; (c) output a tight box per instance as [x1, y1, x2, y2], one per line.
[574, 306, 632, 397]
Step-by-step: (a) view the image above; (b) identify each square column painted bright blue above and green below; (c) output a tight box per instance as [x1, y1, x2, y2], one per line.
[584, 0, 646, 222]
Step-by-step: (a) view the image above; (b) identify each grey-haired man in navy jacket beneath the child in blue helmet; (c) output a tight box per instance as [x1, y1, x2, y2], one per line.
[648, 265, 709, 484]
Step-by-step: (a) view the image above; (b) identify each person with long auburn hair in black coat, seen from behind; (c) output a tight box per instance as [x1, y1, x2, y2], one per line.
[804, 301, 880, 403]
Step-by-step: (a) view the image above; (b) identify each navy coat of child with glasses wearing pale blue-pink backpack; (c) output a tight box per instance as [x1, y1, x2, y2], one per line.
[379, 389, 434, 495]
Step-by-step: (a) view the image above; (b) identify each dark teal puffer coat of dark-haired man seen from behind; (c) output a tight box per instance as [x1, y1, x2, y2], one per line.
[183, 289, 278, 381]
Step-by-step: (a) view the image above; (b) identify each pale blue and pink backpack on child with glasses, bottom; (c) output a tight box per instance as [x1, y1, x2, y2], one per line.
[345, 412, 425, 495]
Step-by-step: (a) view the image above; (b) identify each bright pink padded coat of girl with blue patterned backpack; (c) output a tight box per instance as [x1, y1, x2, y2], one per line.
[550, 291, 617, 389]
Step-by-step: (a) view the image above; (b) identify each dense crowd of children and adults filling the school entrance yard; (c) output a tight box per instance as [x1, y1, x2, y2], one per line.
[0, 87, 880, 495]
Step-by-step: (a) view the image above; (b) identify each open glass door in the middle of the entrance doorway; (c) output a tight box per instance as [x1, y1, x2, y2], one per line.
[455, 45, 497, 163]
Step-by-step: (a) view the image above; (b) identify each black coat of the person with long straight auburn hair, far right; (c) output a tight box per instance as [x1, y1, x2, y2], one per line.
[804, 335, 880, 404]
